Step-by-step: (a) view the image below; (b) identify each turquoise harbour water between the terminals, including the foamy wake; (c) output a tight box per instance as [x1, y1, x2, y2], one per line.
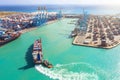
[0, 19, 120, 80]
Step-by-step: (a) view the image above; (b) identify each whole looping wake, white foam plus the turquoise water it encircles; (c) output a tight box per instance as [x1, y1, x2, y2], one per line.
[35, 63, 107, 80]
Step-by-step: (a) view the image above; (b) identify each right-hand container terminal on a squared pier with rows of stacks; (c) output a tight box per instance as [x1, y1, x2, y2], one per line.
[71, 14, 120, 49]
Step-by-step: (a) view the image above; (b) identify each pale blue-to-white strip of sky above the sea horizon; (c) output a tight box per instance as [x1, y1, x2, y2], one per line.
[0, 0, 120, 5]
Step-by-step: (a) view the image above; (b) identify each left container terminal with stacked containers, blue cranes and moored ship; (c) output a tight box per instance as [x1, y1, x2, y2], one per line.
[0, 6, 62, 46]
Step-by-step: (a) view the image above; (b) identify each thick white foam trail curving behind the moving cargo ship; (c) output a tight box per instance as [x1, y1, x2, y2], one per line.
[35, 65, 98, 80]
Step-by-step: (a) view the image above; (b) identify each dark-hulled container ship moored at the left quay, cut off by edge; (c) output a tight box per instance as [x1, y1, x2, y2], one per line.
[0, 32, 21, 46]
